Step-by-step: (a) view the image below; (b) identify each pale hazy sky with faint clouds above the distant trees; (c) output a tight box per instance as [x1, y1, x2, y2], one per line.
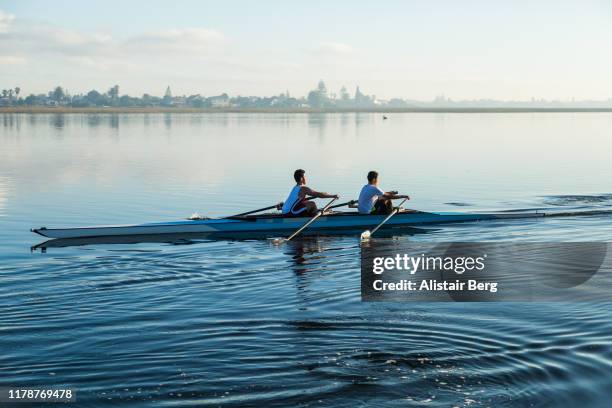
[0, 0, 612, 100]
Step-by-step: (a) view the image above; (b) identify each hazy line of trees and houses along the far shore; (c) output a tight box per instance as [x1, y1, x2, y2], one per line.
[0, 81, 612, 109]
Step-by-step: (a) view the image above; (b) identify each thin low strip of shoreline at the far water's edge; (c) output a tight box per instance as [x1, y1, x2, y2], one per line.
[0, 106, 612, 114]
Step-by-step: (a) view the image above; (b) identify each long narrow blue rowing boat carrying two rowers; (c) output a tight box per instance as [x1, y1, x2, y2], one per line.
[31, 211, 547, 238]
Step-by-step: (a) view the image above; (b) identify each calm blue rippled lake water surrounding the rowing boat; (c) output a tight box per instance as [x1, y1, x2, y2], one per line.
[0, 113, 612, 407]
